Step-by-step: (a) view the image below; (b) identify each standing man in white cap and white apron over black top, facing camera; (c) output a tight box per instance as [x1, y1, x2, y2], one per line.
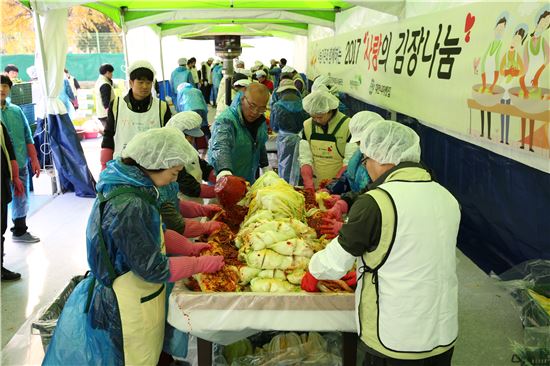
[100, 60, 172, 170]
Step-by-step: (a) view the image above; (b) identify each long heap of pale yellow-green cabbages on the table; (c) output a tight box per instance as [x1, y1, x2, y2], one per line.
[235, 172, 324, 292]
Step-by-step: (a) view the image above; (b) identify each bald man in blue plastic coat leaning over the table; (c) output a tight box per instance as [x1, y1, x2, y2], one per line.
[208, 83, 270, 184]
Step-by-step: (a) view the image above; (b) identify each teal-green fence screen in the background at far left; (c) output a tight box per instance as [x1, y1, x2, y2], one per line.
[0, 53, 126, 81]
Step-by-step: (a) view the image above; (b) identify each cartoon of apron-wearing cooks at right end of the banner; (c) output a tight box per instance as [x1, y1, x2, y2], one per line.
[468, 5, 550, 156]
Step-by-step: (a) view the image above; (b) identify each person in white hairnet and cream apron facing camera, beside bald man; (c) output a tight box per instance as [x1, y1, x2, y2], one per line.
[298, 90, 357, 190]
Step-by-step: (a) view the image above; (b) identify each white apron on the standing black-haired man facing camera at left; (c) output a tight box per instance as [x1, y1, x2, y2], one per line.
[113, 96, 164, 159]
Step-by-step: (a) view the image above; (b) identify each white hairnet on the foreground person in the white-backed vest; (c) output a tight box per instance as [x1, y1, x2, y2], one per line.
[360, 120, 420, 165]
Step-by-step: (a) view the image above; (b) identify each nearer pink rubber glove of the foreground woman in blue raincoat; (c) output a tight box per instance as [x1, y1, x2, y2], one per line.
[168, 255, 225, 282]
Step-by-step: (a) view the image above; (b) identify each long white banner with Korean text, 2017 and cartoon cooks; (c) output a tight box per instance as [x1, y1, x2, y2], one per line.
[308, 1, 550, 173]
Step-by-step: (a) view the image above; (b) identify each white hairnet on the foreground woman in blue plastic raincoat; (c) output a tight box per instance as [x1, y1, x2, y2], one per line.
[121, 127, 194, 170]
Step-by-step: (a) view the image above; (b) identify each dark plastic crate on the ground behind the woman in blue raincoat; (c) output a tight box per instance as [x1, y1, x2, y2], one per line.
[31, 276, 86, 352]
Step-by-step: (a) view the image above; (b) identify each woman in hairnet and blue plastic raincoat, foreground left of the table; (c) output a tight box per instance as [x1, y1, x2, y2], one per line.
[43, 127, 224, 365]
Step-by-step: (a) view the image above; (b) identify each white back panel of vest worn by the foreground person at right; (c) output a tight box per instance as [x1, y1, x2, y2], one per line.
[370, 181, 460, 352]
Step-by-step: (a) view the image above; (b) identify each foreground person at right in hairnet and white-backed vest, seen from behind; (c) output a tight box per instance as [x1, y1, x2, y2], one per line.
[302, 121, 460, 366]
